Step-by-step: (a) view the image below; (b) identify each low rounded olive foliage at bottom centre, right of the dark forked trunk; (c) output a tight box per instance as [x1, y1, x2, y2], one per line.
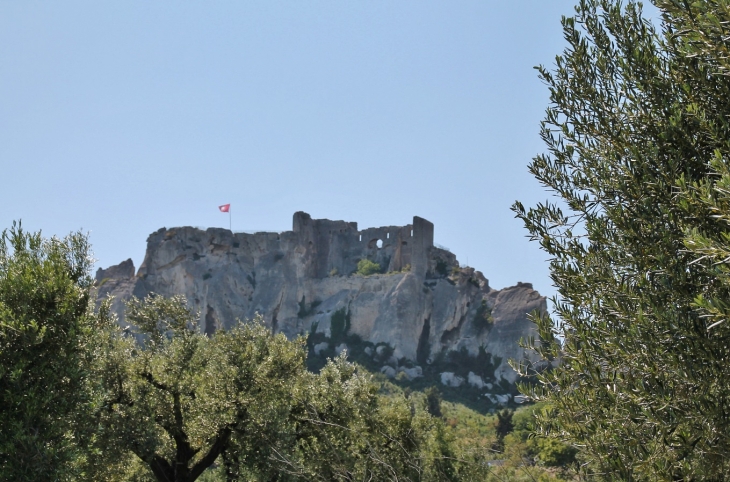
[256, 357, 460, 481]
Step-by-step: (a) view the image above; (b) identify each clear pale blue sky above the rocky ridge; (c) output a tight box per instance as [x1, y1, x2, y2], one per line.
[0, 0, 592, 302]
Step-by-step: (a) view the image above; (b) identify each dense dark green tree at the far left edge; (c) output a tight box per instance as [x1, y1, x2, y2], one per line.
[0, 223, 96, 480]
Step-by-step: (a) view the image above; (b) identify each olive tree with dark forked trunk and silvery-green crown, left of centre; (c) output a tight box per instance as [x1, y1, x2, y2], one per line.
[89, 296, 305, 482]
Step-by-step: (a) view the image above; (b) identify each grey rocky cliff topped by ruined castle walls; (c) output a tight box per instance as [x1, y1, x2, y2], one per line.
[97, 212, 546, 381]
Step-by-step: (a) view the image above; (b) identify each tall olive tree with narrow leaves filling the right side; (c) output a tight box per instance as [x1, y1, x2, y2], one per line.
[514, 0, 730, 480]
